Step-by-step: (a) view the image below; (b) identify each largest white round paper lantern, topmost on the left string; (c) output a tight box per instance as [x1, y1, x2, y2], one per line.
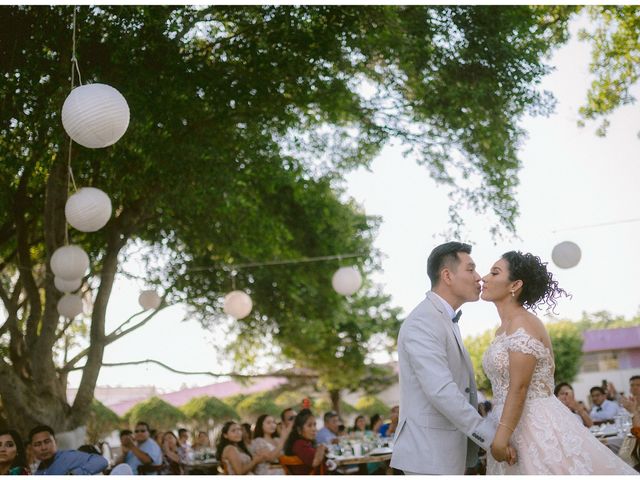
[62, 83, 129, 148]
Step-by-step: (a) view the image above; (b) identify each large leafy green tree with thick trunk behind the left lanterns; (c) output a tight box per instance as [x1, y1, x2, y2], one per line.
[0, 5, 568, 431]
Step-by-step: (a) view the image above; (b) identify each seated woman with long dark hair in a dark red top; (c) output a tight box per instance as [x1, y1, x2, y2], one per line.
[284, 408, 328, 475]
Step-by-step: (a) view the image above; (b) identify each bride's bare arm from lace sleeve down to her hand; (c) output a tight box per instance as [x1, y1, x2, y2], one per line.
[491, 351, 537, 462]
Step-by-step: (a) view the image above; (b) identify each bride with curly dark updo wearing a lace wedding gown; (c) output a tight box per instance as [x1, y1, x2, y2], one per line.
[481, 252, 636, 475]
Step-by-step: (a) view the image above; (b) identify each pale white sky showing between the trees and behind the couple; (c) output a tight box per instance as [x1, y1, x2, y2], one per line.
[70, 13, 640, 391]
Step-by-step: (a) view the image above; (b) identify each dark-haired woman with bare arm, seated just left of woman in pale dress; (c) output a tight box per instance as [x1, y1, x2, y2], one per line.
[216, 421, 267, 475]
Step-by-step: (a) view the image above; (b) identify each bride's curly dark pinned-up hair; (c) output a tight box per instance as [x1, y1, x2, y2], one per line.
[502, 251, 571, 313]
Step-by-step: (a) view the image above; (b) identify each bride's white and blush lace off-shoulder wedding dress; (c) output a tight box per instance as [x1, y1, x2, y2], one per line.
[482, 328, 637, 475]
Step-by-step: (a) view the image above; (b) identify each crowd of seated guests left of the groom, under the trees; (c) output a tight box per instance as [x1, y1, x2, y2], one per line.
[0, 406, 398, 475]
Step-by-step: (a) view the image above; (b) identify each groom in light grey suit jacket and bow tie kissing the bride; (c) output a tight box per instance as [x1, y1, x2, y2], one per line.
[391, 242, 515, 475]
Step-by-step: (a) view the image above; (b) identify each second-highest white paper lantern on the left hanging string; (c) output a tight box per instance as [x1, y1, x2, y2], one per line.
[64, 187, 111, 232]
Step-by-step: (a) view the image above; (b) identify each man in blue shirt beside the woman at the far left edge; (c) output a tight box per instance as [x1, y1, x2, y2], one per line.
[29, 425, 109, 475]
